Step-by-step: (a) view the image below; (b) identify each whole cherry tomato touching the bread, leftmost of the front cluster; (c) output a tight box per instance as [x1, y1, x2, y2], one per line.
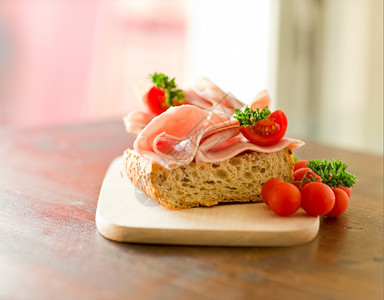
[268, 182, 301, 217]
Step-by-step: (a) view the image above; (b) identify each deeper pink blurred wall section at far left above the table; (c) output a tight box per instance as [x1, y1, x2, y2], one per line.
[0, 0, 99, 126]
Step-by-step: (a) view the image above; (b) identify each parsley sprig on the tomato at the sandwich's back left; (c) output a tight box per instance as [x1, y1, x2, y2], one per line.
[150, 72, 185, 107]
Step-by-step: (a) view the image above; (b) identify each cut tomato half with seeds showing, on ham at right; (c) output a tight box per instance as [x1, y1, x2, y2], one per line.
[240, 110, 288, 146]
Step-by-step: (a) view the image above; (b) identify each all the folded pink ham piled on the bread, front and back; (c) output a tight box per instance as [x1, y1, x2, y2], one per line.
[130, 78, 304, 169]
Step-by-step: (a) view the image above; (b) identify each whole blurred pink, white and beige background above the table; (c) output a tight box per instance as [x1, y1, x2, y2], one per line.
[0, 0, 383, 154]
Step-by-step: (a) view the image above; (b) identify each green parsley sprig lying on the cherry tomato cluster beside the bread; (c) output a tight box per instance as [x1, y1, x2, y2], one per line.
[308, 159, 357, 188]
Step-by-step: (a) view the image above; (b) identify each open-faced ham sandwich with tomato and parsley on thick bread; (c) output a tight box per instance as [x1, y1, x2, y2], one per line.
[123, 73, 304, 209]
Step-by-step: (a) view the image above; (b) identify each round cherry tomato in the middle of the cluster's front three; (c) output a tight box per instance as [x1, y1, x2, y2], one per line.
[301, 182, 335, 216]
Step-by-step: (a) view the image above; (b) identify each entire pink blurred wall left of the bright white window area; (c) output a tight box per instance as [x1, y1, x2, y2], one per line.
[0, 0, 185, 126]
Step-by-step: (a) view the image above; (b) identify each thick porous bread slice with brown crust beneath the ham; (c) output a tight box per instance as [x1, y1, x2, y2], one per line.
[123, 148, 294, 209]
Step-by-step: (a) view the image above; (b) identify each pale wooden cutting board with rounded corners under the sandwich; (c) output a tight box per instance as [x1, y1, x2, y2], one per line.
[96, 157, 319, 246]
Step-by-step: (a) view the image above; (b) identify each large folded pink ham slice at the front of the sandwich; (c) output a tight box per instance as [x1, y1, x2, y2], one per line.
[134, 95, 304, 169]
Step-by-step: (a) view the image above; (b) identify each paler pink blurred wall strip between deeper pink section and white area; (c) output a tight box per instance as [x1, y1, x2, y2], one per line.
[85, 0, 186, 118]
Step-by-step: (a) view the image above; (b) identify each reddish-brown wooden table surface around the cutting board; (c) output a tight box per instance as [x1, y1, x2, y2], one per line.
[0, 121, 383, 299]
